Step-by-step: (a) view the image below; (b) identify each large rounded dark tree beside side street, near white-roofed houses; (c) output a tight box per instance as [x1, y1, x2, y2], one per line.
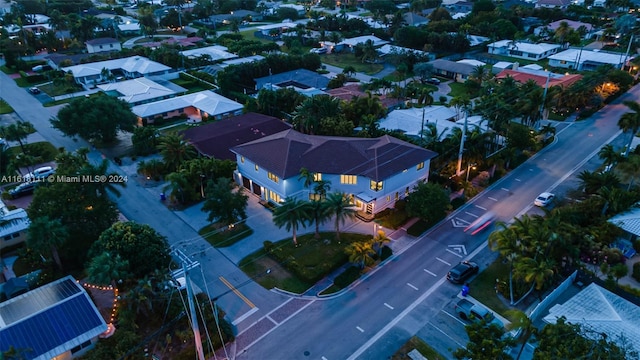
[50, 96, 137, 143]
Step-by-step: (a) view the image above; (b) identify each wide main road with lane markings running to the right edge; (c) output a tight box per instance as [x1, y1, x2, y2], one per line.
[236, 87, 640, 360]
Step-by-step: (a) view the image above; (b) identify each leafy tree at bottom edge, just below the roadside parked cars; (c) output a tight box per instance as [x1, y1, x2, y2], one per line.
[453, 321, 514, 360]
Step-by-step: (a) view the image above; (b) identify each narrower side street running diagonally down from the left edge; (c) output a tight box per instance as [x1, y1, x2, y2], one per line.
[0, 67, 287, 319]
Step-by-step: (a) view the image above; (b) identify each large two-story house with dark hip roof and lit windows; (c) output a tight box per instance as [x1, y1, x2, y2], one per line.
[231, 130, 437, 218]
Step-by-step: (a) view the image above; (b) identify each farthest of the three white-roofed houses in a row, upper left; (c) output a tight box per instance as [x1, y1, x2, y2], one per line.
[61, 56, 172, 84]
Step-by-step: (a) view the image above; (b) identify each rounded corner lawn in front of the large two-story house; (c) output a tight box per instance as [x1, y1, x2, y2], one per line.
[239, 232, 371, 294]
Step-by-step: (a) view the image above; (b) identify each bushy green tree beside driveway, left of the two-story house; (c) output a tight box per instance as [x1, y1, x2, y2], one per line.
[202, 178, 249, 225]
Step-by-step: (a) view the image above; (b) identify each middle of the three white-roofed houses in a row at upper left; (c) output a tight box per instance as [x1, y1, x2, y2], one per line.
[98, 78, 176, 105]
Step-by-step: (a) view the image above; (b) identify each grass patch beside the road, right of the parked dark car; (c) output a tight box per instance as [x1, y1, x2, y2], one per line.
[469, 259, 520, 321]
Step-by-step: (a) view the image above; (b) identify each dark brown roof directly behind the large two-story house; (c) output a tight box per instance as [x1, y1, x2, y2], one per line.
[182, 113, 291, 161]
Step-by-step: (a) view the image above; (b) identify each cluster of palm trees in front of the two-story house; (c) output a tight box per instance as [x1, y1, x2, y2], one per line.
[273, 168, 356, 246]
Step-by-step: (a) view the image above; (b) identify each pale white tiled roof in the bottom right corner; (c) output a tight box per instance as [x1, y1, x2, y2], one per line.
[543, 283, 640, 351]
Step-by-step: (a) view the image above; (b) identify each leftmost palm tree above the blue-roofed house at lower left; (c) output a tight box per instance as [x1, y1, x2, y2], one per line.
[27, 216, 69, 271]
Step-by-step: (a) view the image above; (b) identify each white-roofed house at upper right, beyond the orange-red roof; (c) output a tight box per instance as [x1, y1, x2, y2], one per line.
[549, 49, 633, 70]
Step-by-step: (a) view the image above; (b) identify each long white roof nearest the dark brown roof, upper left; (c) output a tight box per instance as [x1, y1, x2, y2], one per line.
[131, 90, 243, 118]
